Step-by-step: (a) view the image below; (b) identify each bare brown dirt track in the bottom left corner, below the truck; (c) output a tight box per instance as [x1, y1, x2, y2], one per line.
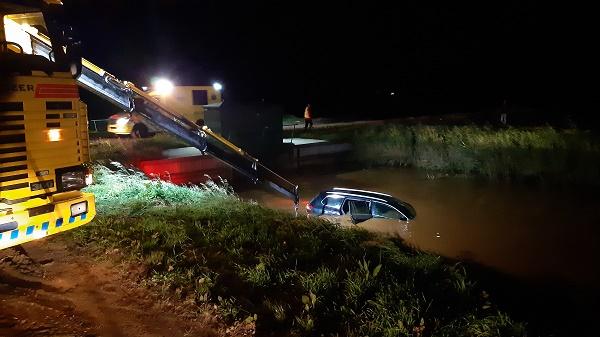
[0, 236, 239, 337]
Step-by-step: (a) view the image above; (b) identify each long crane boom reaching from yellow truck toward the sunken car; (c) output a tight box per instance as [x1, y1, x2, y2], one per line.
[22, 23, 299, 207]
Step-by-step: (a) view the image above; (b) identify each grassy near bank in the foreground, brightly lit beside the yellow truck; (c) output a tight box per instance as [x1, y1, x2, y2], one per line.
[74, 166, 524, 336]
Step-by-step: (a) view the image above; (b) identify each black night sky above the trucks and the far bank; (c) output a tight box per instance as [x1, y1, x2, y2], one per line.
[65, 0, 582, 121]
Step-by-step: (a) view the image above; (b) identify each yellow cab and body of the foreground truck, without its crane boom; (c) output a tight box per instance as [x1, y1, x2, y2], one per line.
[0, 1, 96, 249]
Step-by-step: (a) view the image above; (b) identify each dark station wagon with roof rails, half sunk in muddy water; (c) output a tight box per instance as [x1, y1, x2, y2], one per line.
[306, 187, 417, 234]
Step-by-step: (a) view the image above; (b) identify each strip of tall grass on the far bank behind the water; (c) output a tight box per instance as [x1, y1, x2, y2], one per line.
[301, 124, 600, 184]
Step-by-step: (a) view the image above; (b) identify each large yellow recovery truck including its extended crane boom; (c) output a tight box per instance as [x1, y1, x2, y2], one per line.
[0, 0, 298, 249]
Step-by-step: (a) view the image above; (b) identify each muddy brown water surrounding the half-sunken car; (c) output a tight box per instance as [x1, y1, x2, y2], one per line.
[239, 169, 600, 289]
